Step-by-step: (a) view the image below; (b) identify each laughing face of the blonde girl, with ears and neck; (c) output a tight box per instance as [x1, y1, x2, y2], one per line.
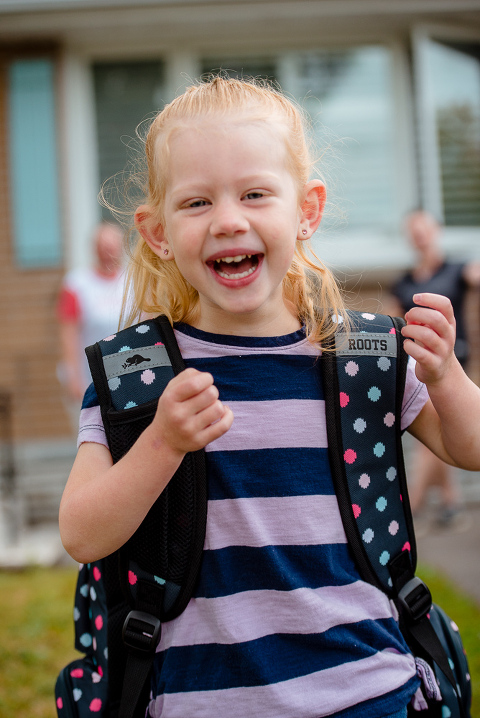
[151, 119, 323, 335]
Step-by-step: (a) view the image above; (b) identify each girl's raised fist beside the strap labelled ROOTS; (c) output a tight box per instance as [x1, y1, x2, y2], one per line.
[402, 293, 459, 385]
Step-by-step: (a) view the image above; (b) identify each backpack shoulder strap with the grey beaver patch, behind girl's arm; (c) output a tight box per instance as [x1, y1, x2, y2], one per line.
[86, 316, 207, 718]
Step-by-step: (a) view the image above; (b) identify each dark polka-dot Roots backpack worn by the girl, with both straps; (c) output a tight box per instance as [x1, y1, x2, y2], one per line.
[55, 312, 471, 718]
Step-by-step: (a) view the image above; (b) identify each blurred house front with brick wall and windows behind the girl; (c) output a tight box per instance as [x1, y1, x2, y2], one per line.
[0, 0, 480, 439]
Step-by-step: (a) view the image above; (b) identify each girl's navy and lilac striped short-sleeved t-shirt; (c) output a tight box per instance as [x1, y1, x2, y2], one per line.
[79, 325, 428, 718]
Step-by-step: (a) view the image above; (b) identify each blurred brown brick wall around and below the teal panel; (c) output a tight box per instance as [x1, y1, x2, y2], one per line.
[0, 52, 71, 439]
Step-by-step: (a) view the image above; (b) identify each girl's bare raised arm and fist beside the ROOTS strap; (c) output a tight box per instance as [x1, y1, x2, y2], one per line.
[402, 293, 480, 471]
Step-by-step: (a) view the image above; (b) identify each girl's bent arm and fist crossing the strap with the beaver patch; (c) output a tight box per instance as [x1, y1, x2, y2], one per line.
[59, 369, 233, 563]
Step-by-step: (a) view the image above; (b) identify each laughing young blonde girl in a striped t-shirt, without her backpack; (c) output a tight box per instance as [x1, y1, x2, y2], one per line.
[60, 78, 480, 718]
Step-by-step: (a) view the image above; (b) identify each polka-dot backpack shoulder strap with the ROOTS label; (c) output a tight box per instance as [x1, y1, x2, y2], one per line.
[322, 312, 462, 704]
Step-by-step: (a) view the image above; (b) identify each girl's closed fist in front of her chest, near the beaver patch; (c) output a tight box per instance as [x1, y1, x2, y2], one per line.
[152, 368, 233, 455]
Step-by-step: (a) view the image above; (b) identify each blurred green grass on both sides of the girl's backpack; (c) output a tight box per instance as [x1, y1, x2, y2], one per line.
[0, 566, 480, 718]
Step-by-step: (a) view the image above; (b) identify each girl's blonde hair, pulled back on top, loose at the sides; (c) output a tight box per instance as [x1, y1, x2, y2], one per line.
[127, 77, 345, 348]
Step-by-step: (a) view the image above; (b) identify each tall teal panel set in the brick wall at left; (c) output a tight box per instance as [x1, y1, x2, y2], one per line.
[8, 59, 62, 268]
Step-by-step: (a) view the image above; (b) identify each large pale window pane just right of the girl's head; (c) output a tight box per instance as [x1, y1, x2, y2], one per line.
[289, 46, 399, 230]
